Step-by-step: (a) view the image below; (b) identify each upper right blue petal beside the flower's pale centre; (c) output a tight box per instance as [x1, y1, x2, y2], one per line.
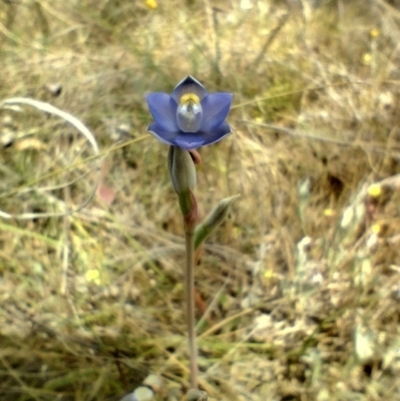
[201, 92, 233, 131]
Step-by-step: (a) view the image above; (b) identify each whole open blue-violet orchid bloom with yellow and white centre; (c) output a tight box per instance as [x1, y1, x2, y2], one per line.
[146, 76, 233, 150]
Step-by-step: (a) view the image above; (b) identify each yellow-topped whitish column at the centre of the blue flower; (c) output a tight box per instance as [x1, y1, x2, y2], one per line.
[176, 93, 203, 132]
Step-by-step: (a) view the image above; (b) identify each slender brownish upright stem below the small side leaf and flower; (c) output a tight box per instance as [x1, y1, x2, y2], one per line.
[185, 224, 198, 389]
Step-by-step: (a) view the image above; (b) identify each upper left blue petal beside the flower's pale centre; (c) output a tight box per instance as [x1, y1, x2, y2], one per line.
[146, 92, 179, 131]
